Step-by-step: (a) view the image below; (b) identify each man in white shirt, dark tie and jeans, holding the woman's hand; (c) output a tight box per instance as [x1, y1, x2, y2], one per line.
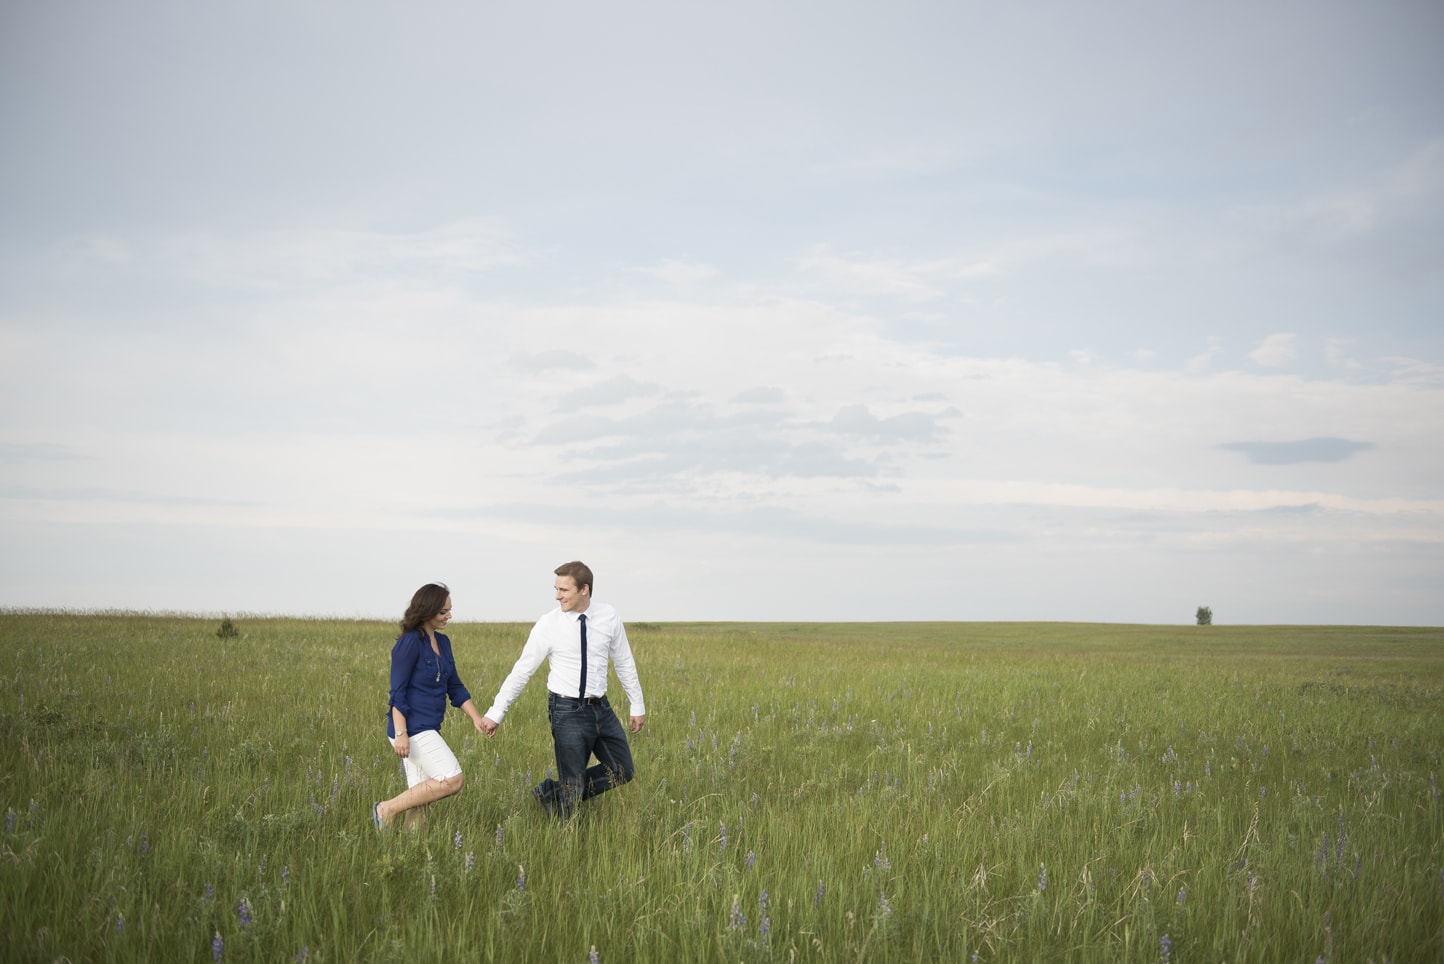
[481, 563, 647, 818]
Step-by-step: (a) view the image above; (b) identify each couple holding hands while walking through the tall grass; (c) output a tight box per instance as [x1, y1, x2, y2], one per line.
[371, 563, 647, 830]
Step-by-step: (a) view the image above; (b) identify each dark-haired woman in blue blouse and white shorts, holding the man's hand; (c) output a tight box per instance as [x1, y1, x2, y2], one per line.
[371, 583, 481, 831]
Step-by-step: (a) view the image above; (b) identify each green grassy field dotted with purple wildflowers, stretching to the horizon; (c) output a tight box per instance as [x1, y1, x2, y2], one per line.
[0, 612, 1444, 964]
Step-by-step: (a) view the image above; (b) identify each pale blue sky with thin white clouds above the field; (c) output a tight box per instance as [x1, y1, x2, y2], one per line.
[0, 0, 1444, 626]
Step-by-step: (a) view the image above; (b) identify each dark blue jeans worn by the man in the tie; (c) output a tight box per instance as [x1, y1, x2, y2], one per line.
[536, 693, 637, 817]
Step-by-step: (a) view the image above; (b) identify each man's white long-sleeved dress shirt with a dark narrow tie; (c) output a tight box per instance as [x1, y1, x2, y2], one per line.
[485, 600, 647, 723]
